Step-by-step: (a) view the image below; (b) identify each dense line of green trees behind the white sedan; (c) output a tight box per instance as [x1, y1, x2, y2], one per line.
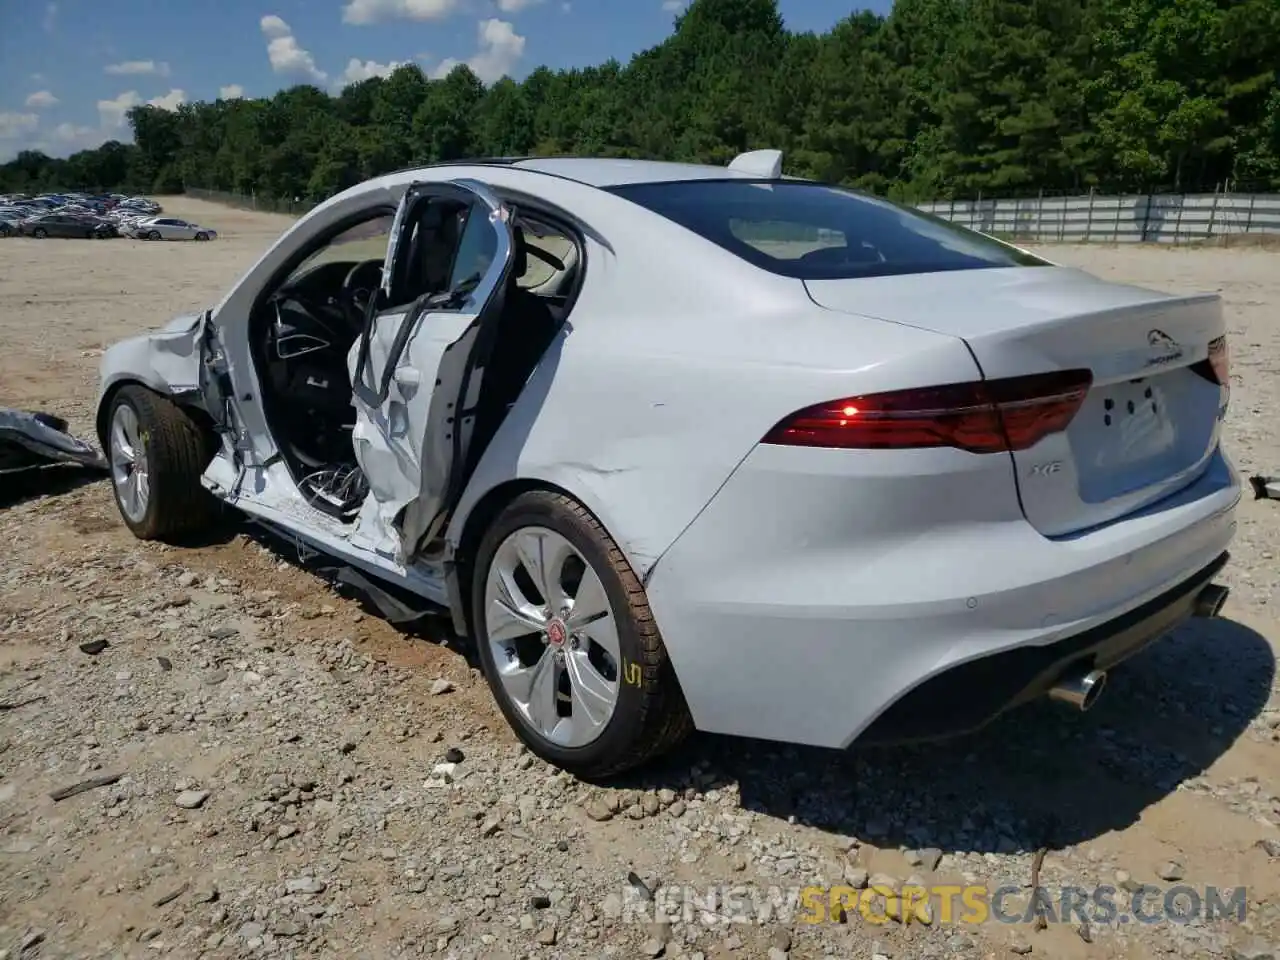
[0, 0, 1280, 201]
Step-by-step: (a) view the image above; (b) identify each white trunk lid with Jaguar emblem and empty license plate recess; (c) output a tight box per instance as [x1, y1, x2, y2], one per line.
[805, 266, 1226, 536]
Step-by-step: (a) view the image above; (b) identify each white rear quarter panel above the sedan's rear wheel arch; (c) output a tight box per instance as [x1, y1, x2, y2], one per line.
[448, 209, 977, 580]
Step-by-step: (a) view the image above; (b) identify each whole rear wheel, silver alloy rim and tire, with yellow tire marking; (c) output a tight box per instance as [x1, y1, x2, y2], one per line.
[471, 492, 692, 780]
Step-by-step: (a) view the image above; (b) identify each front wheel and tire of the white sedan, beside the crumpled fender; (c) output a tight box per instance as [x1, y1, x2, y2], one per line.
[106, 387, 218, 540]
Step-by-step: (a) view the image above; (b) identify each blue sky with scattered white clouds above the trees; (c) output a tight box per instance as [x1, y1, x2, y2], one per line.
[0, 0, 891, 161]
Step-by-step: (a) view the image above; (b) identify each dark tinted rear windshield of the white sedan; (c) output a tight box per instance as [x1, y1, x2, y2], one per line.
[611, 179, 1047, 280]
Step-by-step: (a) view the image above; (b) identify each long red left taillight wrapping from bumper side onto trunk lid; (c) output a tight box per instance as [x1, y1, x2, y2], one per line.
[762, 370, 1093, 453]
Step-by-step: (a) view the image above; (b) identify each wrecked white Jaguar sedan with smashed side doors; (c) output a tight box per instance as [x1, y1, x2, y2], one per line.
[99, 151, 1240, 777]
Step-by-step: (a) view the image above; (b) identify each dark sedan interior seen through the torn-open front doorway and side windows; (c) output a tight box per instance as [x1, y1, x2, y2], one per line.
[250, 200, 581, 522]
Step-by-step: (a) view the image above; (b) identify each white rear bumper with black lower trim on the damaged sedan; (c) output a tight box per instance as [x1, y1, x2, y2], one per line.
[645, 447, 1240, 748]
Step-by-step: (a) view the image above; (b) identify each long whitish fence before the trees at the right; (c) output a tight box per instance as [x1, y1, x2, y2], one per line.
[920, 193, 1280, 243]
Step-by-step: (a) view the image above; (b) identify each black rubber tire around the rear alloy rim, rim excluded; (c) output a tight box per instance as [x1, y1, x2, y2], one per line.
[471, 494, 660, 769]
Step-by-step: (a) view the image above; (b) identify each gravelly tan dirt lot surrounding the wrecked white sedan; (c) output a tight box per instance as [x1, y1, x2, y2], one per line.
[0, 200, 1280, 960]
